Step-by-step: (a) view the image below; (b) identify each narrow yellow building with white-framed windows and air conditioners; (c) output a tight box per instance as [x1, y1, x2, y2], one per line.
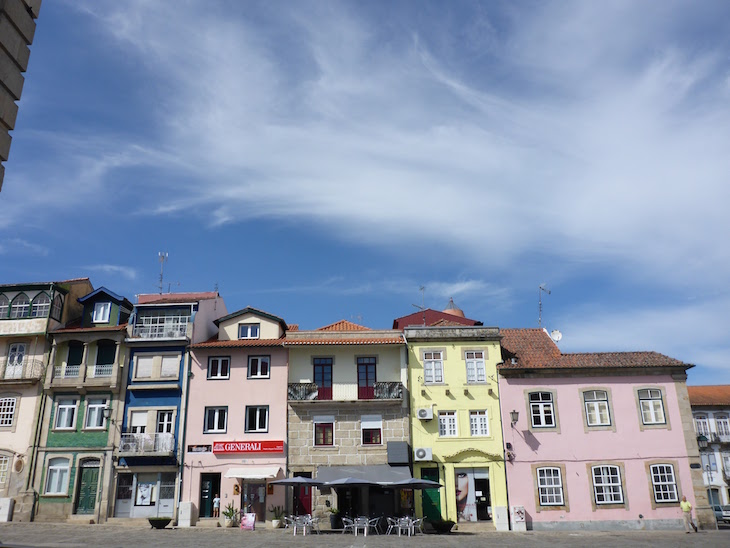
[404, 326, 509, 531]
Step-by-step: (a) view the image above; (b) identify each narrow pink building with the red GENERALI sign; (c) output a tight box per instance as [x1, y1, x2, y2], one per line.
[182, 308, 287, 522]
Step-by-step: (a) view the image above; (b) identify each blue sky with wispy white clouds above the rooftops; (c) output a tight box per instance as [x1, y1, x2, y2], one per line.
[0, 0, 730, 384]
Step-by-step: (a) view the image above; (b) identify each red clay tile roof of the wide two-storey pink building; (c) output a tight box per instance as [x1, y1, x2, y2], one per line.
[499, 329, 693, 371]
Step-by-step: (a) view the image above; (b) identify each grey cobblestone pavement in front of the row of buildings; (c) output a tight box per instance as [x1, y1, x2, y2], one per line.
[0, 523, 730, 548]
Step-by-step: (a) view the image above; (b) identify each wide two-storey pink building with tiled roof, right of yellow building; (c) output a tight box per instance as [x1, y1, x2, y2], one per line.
[499, 329, 715, 530]
